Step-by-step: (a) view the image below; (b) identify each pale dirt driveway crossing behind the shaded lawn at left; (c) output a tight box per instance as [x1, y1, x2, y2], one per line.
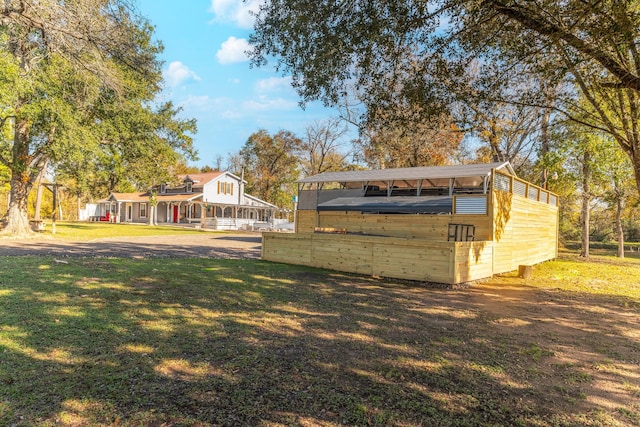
[0, 233, 262, 259]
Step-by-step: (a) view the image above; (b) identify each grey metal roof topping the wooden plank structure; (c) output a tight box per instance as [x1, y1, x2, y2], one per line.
[298, 162, 516, 184]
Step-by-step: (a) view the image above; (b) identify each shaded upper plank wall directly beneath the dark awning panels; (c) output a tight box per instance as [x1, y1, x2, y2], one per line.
[296, 211, 492, 241]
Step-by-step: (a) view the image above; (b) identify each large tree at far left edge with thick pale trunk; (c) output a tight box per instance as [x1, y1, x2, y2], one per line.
[0, 0, 168, 234]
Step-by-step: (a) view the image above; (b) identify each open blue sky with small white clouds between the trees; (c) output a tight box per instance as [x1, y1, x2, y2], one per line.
[137, 0, 350, 166]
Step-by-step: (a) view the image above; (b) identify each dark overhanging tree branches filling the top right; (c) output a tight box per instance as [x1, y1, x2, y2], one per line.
[250, 0, 640, 196]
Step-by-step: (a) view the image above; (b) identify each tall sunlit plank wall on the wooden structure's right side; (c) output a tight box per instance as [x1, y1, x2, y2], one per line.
[493, 191, 558, 274]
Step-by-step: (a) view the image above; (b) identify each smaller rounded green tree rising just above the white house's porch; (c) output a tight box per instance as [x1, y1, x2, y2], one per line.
[55, 99, 197, 198]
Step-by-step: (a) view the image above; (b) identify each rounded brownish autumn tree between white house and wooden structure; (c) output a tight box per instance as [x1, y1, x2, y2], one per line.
[240, 130, 302, 210]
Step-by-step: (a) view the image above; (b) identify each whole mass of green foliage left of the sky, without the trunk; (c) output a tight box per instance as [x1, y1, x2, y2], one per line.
[0, 0, 196, 213]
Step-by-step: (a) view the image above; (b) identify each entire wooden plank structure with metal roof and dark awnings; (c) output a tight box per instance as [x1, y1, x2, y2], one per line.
[262, 163, 558, 284]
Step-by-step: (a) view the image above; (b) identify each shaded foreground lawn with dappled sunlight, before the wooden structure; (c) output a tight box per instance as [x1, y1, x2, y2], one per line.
[0, 258, 640, 426]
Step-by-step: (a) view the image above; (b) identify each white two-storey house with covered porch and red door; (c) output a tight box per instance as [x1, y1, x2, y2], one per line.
[92, 172, 280, 230]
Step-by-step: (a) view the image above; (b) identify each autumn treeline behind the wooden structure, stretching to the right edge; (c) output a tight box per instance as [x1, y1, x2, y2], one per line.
[198, 112, 640, 256]
